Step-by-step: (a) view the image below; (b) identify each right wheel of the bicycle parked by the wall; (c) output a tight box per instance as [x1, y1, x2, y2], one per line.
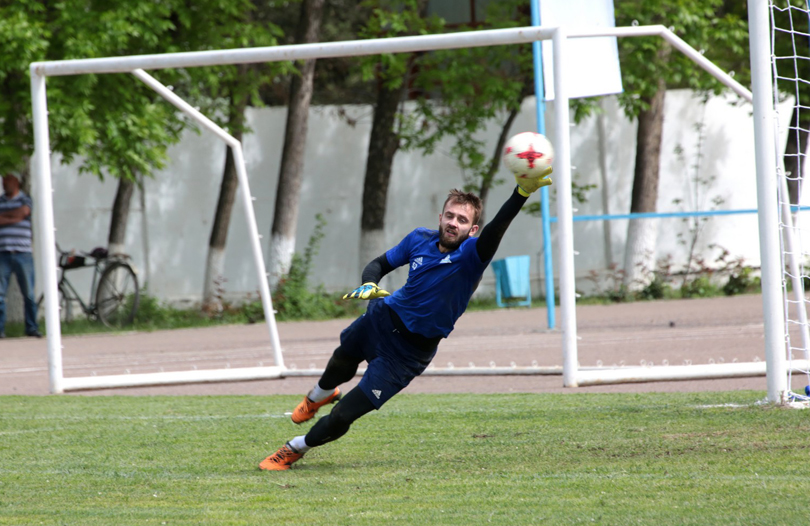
[96, 261, 140, 329]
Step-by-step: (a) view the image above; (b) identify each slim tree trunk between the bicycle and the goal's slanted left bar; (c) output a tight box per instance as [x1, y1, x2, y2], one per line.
[202, 64, 248, 313]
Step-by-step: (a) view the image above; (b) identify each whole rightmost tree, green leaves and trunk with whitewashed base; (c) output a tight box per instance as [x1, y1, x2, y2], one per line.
[616, 0, 748, 288]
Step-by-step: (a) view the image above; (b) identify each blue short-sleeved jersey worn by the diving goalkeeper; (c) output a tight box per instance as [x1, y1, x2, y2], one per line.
[385, 228, 489, 338]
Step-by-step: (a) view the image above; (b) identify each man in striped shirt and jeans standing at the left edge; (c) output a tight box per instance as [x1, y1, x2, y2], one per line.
[0, 172, 42, 338]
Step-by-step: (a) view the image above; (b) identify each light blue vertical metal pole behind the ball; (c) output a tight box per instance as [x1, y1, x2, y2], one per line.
[531, 0, 556, 329]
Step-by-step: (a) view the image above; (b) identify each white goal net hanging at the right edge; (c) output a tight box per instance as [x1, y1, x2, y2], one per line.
[770, 0, 810, 402]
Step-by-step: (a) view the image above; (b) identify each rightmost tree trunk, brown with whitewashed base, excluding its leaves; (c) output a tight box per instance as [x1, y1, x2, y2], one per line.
[624, 79, 666, 290]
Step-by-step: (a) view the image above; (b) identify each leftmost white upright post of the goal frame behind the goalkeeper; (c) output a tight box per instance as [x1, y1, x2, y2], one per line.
[31, 67, 63, 394]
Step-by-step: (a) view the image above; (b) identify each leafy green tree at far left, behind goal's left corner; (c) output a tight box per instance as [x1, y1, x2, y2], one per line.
[0, 0, 191, 288]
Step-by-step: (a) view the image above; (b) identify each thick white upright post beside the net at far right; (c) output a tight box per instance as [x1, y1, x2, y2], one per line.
[748, 0, 787, 403]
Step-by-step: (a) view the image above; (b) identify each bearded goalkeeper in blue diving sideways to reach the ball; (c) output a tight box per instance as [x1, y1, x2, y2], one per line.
[259, 168, 551, 470]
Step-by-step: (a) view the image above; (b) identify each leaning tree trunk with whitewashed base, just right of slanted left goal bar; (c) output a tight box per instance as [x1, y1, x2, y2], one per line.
[268, 0, 325, 290]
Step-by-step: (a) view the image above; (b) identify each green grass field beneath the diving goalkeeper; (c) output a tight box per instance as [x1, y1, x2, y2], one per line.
[0, 391, 810, 526]
